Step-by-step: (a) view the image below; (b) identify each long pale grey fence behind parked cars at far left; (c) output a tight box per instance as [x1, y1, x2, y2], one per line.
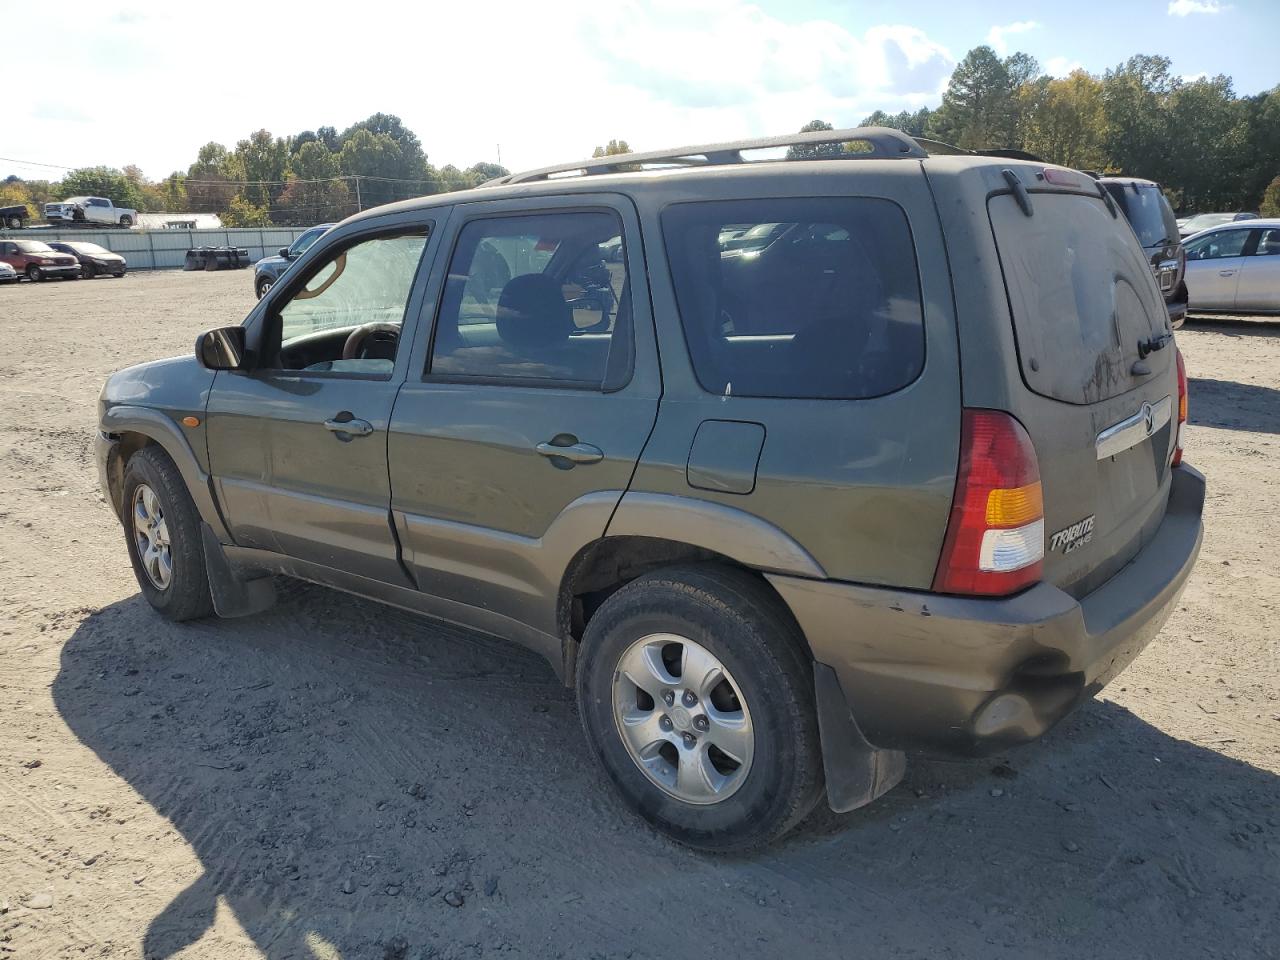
[0, 227, 308, 270]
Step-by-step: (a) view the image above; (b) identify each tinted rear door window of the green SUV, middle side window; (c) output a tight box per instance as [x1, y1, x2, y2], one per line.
[426, 211, 631, 387]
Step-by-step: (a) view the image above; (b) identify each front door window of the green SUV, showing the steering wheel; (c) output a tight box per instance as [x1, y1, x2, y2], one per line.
[268, 230, 426, 376]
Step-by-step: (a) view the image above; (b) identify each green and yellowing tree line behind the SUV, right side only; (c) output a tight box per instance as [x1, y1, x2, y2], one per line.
[801, 46, 1280, 216]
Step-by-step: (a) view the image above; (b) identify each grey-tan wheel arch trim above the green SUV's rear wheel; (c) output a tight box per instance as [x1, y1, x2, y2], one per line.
[608, 493, 827, 580]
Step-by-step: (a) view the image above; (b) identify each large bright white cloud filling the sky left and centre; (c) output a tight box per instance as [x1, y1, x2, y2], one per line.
[0, 0, 955, 178]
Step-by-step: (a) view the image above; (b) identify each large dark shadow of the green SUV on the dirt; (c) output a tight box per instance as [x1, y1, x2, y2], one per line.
[52, 585, 1280, 960]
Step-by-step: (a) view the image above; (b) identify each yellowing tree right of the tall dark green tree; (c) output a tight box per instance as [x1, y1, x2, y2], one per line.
[1018, 70, 1106, 170]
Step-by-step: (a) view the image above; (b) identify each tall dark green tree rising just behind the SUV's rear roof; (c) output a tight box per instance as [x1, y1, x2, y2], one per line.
[928, 45, 1039, 150]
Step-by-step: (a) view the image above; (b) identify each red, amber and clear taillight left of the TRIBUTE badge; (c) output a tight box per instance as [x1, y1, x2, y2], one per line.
[933, 410, 1044, 596]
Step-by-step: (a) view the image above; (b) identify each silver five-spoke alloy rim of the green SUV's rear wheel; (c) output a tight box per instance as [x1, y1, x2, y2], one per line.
[613, 634, 755, 805]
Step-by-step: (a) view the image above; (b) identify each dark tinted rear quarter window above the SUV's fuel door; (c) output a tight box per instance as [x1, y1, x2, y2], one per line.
[662, 197, 924, 399]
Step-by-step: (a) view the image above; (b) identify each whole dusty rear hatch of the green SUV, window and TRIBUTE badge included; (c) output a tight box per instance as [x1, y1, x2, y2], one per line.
[988, 165, 1178, 596]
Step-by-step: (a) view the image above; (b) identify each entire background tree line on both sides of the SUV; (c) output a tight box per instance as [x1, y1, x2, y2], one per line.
[0, 46, 1280, 227]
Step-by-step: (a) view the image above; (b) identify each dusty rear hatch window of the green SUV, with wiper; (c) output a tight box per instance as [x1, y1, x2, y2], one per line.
[988, 193, 1169, 403]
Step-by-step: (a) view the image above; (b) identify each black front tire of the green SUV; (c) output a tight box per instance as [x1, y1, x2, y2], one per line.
[122, 445, 214, 621]
